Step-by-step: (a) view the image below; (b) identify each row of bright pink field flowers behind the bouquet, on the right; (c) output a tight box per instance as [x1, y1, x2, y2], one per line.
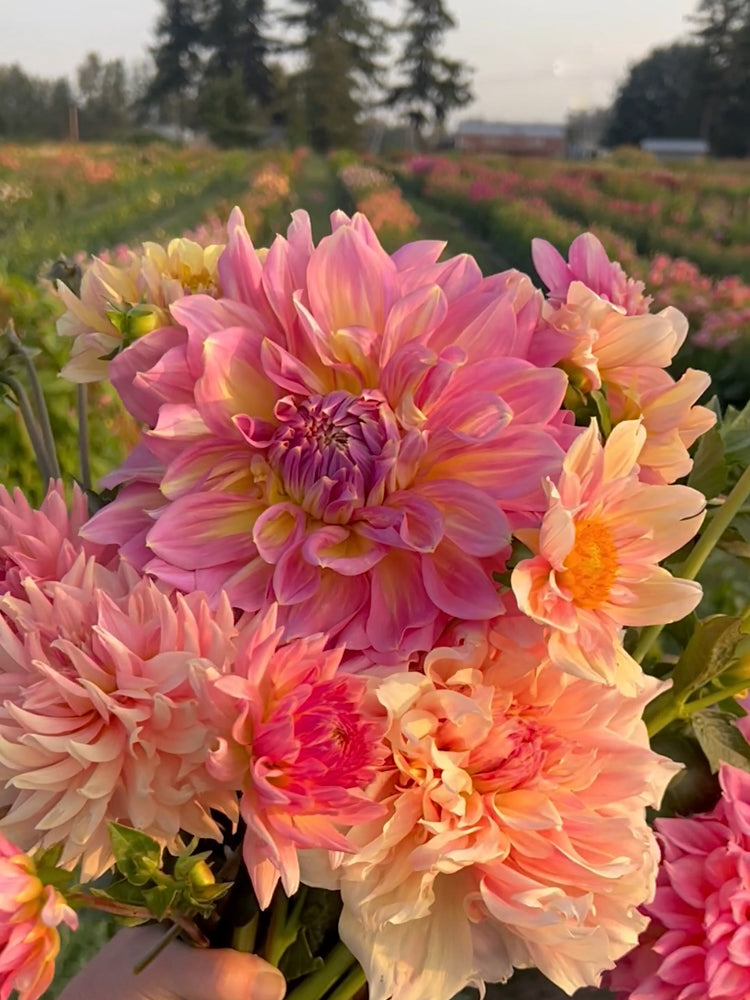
[399, 157, 750, 402]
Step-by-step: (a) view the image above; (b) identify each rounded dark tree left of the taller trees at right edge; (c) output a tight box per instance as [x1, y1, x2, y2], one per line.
[604, 43, 706, 146]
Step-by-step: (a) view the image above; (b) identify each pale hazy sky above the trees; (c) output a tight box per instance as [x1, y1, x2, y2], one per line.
[0, 0, 698, 122]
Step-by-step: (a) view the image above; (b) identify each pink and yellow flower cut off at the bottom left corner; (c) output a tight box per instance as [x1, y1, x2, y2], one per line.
[0, 834, 78, 1000]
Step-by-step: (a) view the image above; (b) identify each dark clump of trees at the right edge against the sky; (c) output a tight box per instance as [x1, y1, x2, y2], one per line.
[603, 0, 750, 157]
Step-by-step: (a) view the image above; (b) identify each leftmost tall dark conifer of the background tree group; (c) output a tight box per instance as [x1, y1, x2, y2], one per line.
[144, 0, 204, 126]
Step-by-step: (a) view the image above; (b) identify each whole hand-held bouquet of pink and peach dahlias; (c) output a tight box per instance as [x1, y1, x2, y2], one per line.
[0, 203, 750, 1000]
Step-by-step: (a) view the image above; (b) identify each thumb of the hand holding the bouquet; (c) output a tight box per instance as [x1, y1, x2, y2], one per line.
[151, 942, 286, 1000]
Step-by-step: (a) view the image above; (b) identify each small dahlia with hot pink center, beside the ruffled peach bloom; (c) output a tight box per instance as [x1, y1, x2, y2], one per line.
[206, 605, 385, 907]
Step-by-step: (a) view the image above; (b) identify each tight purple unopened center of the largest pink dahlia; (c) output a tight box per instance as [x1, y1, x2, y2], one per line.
[268, 390, 400, 522]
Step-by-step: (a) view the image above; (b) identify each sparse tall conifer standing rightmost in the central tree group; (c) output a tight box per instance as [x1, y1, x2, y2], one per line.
[387, 0, 473, 142]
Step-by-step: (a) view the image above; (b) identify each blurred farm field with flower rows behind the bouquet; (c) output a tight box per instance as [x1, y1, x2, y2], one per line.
[5, 146, 750, 1000]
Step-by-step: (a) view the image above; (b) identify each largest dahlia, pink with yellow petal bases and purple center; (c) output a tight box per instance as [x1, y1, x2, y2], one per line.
[87, 210, 575, 662]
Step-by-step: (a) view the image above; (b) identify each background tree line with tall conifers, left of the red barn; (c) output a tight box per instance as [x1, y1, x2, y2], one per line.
[0, 0, 472, 150]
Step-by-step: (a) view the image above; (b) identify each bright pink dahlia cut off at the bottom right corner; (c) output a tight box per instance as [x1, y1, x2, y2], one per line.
[610, 764, 750, 1000]
